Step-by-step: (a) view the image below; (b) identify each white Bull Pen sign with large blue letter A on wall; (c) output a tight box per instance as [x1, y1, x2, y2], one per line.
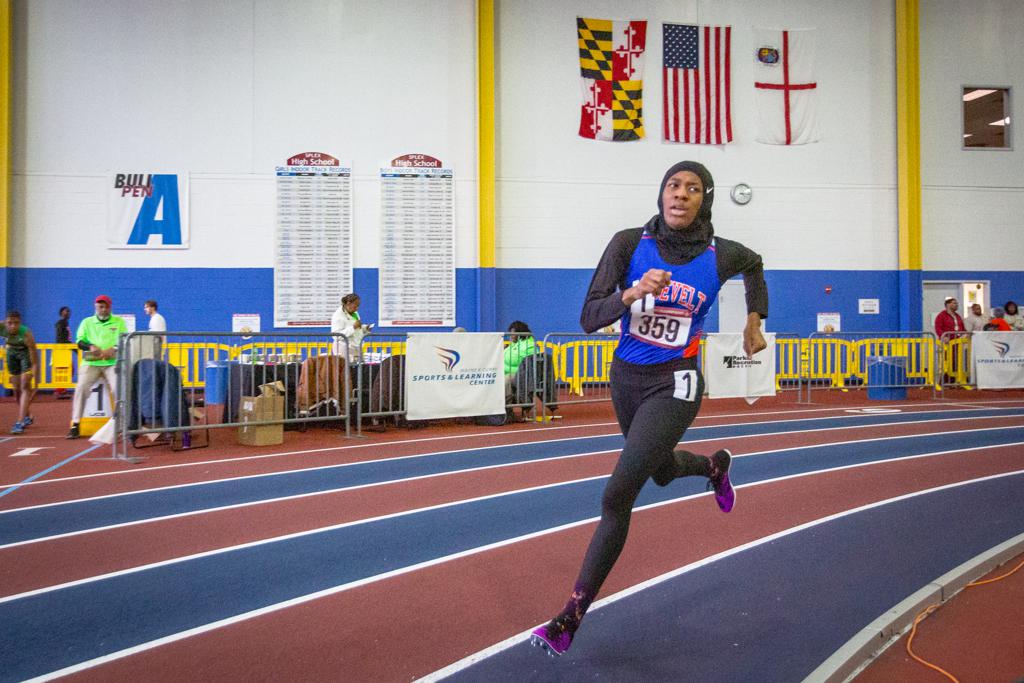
[106, 172, 188, 249]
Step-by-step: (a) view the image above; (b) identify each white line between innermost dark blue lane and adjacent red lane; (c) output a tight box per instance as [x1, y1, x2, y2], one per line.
[416, 470, 1024, 683]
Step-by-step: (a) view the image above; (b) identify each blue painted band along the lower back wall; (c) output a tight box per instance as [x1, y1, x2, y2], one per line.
[6, 268, 1024, 342]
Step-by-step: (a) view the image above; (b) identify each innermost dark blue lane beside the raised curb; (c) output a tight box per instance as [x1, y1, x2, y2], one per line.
[450, 474, 1024, 683]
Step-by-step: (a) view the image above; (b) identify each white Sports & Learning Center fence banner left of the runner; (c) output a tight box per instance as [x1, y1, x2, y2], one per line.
[406, 332, 505, 420]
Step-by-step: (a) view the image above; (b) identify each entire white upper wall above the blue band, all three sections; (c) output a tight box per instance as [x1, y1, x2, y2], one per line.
[10, 0, 1024, 282]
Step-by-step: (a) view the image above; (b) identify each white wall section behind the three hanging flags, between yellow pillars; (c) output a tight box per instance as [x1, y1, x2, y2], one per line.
[498, 0, 898, 269]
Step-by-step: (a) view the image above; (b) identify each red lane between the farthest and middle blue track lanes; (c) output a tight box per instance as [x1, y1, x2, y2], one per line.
[8, 418, 1020, 597]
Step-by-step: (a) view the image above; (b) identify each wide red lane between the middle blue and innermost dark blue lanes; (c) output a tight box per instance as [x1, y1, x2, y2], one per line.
[61, 450, 1024, 680]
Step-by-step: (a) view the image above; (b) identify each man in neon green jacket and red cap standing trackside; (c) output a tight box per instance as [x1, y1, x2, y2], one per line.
[68, 294, 128, 438]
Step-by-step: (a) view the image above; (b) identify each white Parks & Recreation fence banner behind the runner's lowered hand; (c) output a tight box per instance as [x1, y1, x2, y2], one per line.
[705, 334, 775, 398]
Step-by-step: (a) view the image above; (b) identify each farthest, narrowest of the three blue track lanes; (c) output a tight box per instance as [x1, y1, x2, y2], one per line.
[0, 410, 1024, 546]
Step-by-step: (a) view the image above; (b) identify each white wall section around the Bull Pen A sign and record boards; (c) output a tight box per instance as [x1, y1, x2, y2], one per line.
[10, 0, 477, 267]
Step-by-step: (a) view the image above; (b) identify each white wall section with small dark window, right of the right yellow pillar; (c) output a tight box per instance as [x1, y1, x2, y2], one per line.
[921, 0, 1024, 270]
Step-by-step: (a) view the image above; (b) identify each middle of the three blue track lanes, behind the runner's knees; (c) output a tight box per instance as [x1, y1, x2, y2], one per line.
[0, 427, 1024, 680]
